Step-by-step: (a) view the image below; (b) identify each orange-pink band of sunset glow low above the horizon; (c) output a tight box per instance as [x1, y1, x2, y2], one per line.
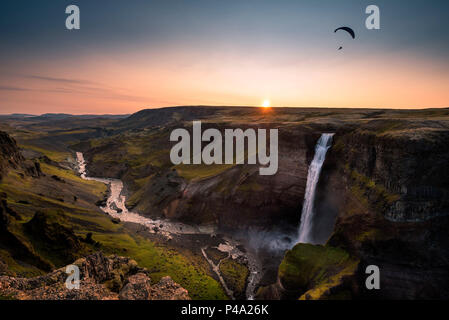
[0, 45, 449, 114]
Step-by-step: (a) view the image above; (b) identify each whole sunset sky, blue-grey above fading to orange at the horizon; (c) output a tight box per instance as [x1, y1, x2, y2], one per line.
[0, 0, 449, 114]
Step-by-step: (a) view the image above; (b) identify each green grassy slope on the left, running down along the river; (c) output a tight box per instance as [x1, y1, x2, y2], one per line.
[0, 131, 226, 299]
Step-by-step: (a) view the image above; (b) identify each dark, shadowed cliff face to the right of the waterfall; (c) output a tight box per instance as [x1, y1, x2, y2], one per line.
[286, 121, 449, 299]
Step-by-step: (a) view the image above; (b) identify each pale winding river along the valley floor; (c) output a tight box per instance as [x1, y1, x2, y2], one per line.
[76, 152, 262, 300]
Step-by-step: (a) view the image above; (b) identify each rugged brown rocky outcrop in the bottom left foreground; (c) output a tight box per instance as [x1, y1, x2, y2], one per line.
[0, 252, 190, 300]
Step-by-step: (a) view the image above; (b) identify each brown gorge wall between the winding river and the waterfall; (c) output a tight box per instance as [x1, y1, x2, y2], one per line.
[81, 123, 321, 240]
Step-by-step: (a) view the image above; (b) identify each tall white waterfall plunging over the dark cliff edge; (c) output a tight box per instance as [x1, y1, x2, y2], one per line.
[298, 133, 334, 243]
